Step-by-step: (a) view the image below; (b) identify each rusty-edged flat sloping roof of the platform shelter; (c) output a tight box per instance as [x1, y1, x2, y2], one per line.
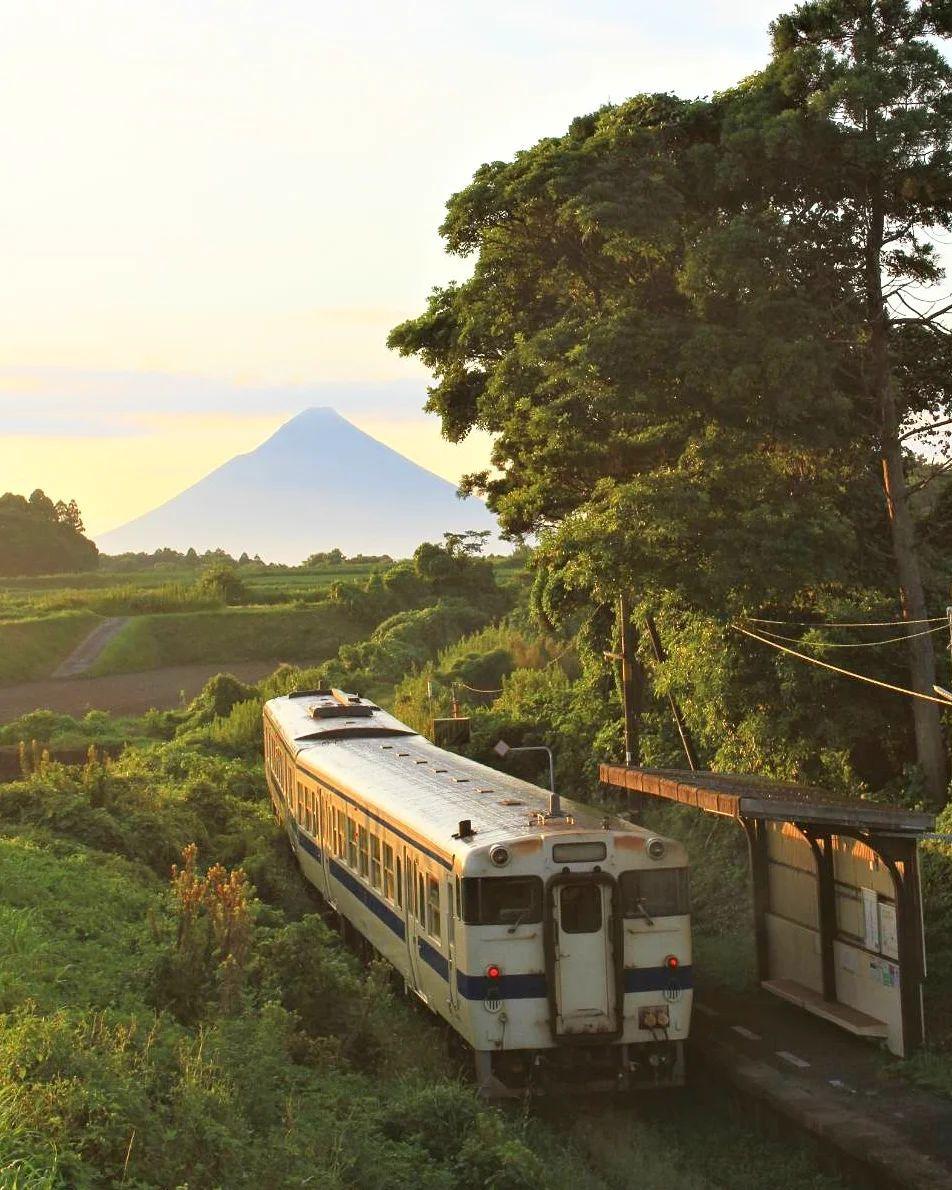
[599, 764, 935, 834]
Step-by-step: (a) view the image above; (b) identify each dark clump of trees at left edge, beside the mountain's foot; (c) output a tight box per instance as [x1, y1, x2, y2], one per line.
[0, 488, 99, 575]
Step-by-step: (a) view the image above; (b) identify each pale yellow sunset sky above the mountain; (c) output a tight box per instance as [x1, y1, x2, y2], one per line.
[0, 0, 789, 534]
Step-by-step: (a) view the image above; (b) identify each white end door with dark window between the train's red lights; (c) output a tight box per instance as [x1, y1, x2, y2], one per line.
[546, 876, 622, 1036]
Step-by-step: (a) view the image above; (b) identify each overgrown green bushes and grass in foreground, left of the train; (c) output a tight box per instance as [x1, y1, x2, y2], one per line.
[0, 683, 838, 1190]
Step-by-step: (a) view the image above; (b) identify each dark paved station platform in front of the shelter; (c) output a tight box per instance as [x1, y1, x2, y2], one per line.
[691, 985, 952, 1190]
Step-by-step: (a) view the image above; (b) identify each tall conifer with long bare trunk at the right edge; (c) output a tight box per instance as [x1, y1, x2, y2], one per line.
[737, 0, 952, 803]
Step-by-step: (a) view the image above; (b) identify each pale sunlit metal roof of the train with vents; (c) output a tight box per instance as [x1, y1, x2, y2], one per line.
[265, 690, 652, 854]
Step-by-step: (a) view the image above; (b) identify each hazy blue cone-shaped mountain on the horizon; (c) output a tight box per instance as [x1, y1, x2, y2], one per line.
[96, 408, 496, 563]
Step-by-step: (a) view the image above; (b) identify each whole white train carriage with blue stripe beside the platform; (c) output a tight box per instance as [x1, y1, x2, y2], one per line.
[263, 689, 693, 1098]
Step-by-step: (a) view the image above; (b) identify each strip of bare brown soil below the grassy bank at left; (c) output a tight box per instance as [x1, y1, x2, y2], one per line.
[0, 660, 295, 724]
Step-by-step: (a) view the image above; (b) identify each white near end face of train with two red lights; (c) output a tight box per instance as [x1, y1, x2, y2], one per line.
[457, 816, 691, 1095]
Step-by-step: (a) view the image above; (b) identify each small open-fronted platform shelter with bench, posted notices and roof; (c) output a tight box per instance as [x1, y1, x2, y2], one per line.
[600, 764, 935, 1056]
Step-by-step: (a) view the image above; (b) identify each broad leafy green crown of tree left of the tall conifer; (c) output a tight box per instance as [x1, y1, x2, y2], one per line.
[390, 95, 871, 606]
